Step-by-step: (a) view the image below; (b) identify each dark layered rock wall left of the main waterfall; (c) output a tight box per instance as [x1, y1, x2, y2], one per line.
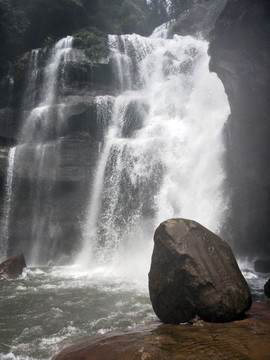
[0, 28, 116, 265]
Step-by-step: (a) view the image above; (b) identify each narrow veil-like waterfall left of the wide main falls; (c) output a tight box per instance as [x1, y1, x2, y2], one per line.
[21, 36, 73, 264]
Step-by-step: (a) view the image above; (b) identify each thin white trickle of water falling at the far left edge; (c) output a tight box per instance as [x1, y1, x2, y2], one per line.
[0, 147, 16, 263]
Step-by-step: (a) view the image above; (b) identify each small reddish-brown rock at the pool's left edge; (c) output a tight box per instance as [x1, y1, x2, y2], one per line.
[0, 254, 26, 280]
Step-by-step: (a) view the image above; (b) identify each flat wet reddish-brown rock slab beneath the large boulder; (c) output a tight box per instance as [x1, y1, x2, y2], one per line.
[53, 303, 270, 360]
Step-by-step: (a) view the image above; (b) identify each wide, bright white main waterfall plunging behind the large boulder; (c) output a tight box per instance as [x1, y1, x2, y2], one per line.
[77, 26, 229, 271]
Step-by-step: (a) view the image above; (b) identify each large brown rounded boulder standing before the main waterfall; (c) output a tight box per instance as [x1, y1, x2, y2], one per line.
[149, 219, 252, 323]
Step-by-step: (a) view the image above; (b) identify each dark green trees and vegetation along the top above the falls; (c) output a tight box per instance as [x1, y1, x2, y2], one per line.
[0, 0, 205, 76]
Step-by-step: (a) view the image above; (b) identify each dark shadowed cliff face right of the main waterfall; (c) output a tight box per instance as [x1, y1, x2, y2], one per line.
[209, 0, 270, 255]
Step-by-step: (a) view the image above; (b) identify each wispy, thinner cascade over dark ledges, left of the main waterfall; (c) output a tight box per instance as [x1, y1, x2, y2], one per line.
[5, 36, 73, 265]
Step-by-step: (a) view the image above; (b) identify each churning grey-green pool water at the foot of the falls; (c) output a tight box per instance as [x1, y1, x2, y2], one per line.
[0, 264, 269, 360]
